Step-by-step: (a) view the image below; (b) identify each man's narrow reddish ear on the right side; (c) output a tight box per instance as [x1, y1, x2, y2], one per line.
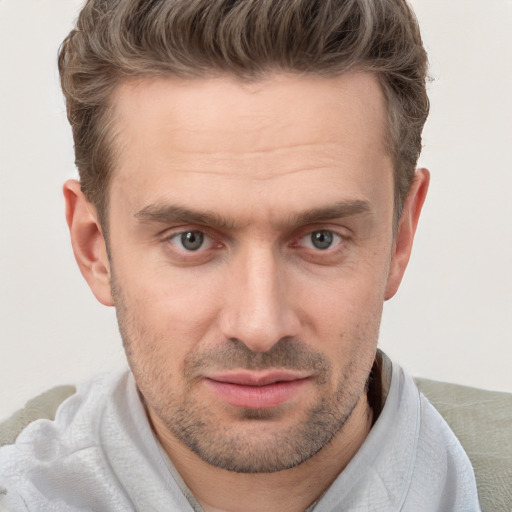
[384, 169, 430, 300]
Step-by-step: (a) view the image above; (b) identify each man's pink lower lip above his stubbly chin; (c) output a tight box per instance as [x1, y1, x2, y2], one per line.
[206, 379, 309, 409]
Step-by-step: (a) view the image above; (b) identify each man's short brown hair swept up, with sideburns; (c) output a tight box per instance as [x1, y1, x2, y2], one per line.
[59, 0, 429, 227]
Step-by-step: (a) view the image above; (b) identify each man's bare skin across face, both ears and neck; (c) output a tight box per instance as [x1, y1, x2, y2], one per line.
[64, 72, 428, 511]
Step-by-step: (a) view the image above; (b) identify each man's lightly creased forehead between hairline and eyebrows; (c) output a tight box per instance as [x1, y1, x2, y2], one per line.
[113, 72, 392, 222]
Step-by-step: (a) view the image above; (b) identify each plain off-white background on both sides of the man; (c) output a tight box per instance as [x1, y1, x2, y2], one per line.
[0, 0, 512, 419]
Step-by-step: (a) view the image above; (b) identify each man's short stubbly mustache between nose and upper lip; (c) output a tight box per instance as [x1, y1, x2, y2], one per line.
[185, 337, 331, 378]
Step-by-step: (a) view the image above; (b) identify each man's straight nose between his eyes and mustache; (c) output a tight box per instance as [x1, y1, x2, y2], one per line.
[220, 247, 300, 352]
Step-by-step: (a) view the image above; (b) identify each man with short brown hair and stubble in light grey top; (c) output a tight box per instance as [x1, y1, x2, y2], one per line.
[0, 0, 479, 512]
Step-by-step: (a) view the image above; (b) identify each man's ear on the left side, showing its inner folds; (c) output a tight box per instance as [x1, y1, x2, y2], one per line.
[63, 180, 114, 306]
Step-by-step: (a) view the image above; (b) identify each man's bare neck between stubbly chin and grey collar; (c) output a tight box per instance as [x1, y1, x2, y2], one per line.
[149, 394, 372, 512]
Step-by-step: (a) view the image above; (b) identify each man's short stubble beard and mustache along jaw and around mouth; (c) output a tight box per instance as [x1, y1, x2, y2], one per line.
[113, 280, 368, 473]
